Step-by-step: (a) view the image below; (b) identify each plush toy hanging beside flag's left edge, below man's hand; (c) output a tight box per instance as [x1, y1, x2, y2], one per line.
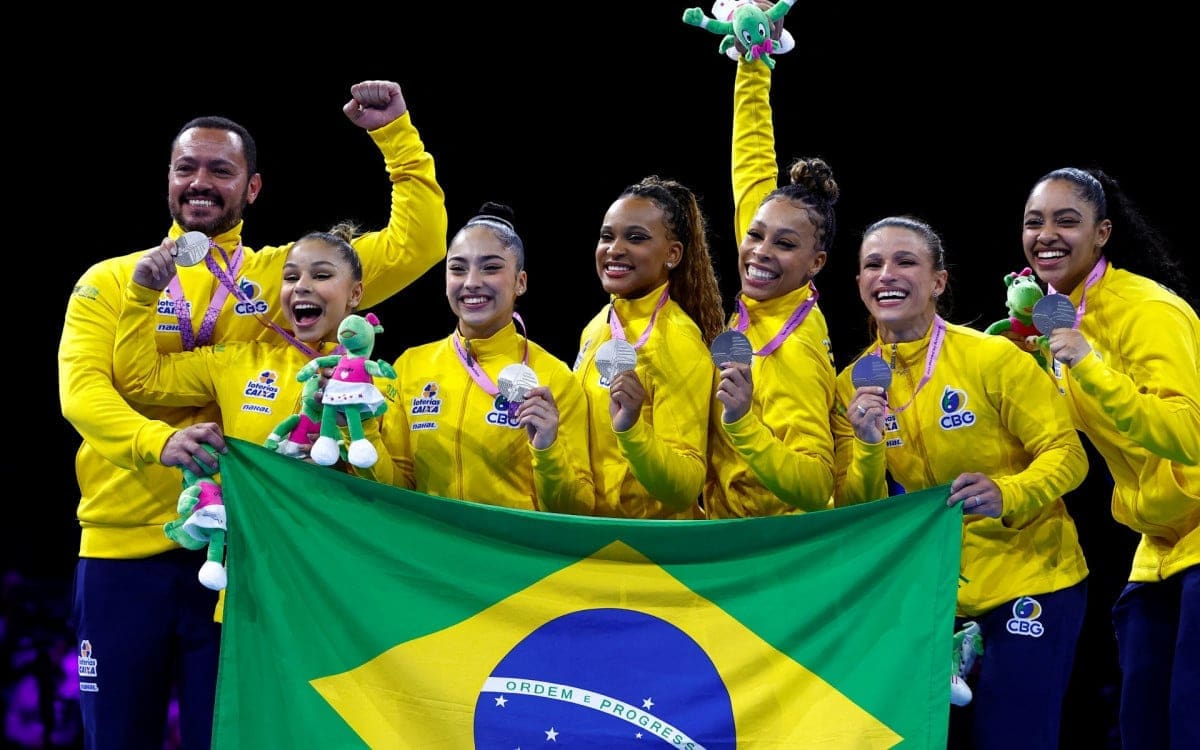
[162, 445, 228, 592]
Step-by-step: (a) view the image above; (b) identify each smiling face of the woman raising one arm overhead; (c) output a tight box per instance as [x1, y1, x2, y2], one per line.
[738, 198, 827, 300]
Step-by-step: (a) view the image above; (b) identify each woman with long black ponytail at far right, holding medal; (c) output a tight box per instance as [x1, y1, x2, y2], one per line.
[1022, 168, 1200, 750]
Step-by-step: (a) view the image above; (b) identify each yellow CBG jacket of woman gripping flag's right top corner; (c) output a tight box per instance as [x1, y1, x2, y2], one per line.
[833, 324, 1087, 617]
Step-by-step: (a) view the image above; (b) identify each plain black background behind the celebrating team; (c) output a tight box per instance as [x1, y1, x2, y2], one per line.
[14, 1, 1198, 746]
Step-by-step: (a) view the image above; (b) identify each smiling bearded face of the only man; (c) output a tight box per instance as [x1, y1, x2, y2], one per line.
[167, 127, 263, 236]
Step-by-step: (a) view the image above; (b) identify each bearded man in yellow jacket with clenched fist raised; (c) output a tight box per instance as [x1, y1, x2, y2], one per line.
[59, 80, 446, 750]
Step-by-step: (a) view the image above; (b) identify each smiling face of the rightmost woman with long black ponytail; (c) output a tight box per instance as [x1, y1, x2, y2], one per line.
[1021, 180, 1112, 294]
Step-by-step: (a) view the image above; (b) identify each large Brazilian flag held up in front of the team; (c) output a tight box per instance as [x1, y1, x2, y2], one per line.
[214, 440, 962, 750]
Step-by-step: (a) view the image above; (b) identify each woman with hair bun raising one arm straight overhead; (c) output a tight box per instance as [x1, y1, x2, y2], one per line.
[704, 45, 839, 518]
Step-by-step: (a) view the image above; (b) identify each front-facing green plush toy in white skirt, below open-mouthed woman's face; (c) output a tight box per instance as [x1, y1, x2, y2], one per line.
[296, 313, 396, 468]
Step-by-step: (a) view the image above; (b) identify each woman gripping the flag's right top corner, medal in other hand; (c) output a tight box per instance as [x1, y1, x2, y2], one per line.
[833, 216, 1087, 750]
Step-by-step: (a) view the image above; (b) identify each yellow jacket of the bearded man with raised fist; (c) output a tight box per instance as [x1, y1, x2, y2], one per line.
[59, 113, 446, 558]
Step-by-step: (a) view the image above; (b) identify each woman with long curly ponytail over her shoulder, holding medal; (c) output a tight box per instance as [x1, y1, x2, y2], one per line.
[574, 176, 724, 518]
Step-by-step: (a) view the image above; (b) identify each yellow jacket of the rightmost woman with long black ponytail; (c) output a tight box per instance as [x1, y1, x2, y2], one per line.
[1054, 265, 1200, 581]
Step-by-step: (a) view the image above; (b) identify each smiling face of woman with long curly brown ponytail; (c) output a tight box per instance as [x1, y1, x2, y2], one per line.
[596, 196, 683, 299]
